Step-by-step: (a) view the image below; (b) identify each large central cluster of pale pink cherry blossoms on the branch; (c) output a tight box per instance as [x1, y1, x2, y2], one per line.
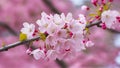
[20, 12, 94, 60]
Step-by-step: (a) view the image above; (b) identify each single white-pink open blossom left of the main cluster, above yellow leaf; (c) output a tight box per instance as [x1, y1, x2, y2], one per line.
[21, 22, 35, 39]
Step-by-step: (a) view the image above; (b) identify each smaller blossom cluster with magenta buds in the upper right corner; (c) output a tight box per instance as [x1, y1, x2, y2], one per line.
[90, 0, 120, 29]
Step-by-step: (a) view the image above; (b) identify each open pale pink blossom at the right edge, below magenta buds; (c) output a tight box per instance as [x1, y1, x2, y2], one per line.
[101, 10, 120, 28]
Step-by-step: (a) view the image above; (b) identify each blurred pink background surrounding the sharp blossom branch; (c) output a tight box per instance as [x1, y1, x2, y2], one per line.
[0, 0, 120, 68]
